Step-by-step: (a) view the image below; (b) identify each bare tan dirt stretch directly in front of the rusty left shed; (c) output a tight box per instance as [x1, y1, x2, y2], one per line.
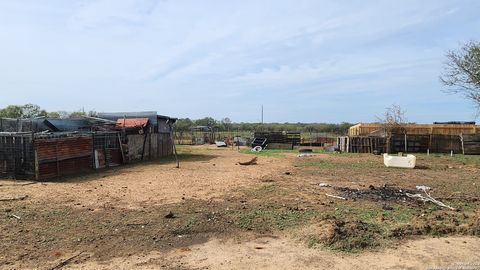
[0, 146, 290, 209]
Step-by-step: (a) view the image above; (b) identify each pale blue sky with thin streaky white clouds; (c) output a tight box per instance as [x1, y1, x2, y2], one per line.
[0, 0, 480, 123]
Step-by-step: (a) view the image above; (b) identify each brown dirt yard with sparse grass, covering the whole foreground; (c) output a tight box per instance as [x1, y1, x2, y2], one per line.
[0, 146, 480, 269]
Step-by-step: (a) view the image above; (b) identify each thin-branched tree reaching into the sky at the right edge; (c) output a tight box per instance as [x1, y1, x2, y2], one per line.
[440, 41, 480, 107]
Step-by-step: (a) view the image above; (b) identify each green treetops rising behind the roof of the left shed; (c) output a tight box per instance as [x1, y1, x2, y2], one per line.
[0, 104, 96, 118]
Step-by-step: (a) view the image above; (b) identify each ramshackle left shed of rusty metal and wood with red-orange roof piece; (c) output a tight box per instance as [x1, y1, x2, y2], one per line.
[0, 110, 176, 180]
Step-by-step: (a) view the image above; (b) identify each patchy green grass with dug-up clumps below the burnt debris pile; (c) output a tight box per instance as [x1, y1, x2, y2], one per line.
[306, 202, 479, 253]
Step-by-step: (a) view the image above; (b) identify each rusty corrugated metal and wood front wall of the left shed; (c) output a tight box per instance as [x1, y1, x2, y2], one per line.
[0, 128, 173, 180]
